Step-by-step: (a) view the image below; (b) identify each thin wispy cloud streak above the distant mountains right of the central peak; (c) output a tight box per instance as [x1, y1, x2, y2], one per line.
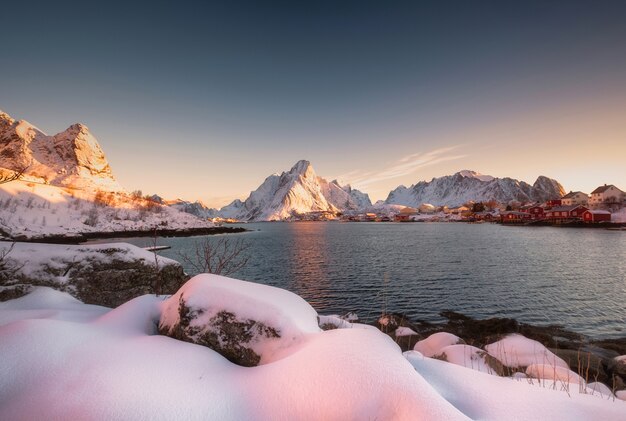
[338, 145, 467, 188]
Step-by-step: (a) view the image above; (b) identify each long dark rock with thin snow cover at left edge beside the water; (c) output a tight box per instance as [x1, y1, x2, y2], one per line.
[0, 242, 188, 307]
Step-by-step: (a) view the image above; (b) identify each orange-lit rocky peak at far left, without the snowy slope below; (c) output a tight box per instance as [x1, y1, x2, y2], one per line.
[0, 111, 123, 191]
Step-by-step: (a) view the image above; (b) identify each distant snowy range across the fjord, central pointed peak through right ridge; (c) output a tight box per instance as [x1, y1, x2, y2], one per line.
[212, 161, 565, 221]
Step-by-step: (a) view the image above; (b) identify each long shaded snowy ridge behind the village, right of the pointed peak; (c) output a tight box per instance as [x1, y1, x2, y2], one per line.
[385, 170, 565, 207]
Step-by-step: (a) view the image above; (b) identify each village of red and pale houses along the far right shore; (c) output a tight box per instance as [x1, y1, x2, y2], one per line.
[256, 184, 626, 226]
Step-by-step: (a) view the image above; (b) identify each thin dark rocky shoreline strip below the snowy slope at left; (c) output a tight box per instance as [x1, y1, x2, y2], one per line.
[9, 227, 248, 244]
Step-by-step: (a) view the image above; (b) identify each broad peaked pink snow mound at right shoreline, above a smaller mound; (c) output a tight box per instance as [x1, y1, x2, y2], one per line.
[485, 333, 569, 369]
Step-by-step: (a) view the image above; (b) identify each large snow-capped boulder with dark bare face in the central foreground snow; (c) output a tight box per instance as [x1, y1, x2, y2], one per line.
[159, 274, 320, 367]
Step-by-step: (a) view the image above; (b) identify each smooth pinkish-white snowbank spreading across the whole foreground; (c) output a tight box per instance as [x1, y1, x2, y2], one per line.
[0, 277, 626, 420]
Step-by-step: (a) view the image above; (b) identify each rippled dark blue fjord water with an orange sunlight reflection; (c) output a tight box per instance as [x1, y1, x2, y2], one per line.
[134, 222, 626, 338]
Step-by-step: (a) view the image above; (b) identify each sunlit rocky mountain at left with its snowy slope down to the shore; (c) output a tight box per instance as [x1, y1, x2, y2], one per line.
[0, 112, 212, 238]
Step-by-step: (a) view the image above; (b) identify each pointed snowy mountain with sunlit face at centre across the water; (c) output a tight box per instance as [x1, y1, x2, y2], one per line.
[220, 160, 371, 221]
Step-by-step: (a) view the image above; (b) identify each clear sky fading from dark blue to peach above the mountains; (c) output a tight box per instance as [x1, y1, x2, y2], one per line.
[0, 0, 626, 207]
